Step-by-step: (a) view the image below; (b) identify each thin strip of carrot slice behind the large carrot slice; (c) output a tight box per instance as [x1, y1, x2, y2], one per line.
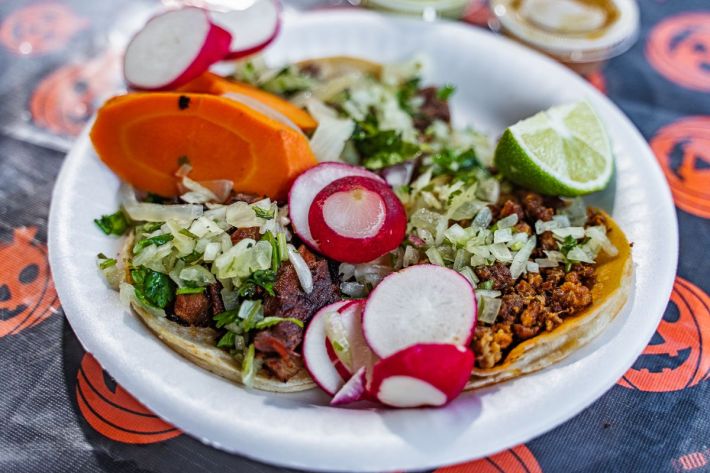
[178, 72, 318, 132]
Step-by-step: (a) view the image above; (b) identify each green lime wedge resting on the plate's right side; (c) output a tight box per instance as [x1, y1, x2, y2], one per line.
[495, 102, 614, 196]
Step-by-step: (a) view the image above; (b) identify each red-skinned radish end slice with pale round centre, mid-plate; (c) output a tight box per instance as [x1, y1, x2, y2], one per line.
[308, 176, 407, 264]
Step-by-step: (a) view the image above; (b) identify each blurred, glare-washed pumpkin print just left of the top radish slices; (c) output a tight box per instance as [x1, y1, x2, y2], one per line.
[30, 54, 120, 136]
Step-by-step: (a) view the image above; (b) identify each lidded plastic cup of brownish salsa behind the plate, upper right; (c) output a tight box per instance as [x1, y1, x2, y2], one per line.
[491, 0, 639, 74]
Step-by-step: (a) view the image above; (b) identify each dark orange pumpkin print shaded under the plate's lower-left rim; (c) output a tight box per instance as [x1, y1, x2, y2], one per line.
[76, 353, 182, 444]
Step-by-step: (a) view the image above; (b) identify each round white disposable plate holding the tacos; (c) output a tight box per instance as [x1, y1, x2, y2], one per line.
[49, 11, 678, 471]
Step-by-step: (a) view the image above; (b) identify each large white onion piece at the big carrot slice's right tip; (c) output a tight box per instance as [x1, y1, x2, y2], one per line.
[307, 99, 355, 162]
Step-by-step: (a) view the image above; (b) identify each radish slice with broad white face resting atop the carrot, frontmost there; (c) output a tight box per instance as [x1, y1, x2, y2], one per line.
[123, 7, 232, 90]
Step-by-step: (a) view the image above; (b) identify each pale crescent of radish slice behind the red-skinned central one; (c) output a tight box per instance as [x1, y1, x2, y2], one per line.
[288, 162, 384, 251]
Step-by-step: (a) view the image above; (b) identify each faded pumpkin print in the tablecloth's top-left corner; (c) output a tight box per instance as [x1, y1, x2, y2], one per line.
[0, 2, 89, 55]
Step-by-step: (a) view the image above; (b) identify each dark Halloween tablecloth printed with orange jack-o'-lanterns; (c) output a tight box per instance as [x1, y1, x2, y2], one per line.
[0, 0, 710, 473]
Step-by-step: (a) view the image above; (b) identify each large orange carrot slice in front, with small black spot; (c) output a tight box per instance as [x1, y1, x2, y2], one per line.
[91, 92, 317, 199]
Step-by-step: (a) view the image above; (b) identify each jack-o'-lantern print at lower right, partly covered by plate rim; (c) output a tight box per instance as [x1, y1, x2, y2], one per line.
[619, 277, 710, 392]
